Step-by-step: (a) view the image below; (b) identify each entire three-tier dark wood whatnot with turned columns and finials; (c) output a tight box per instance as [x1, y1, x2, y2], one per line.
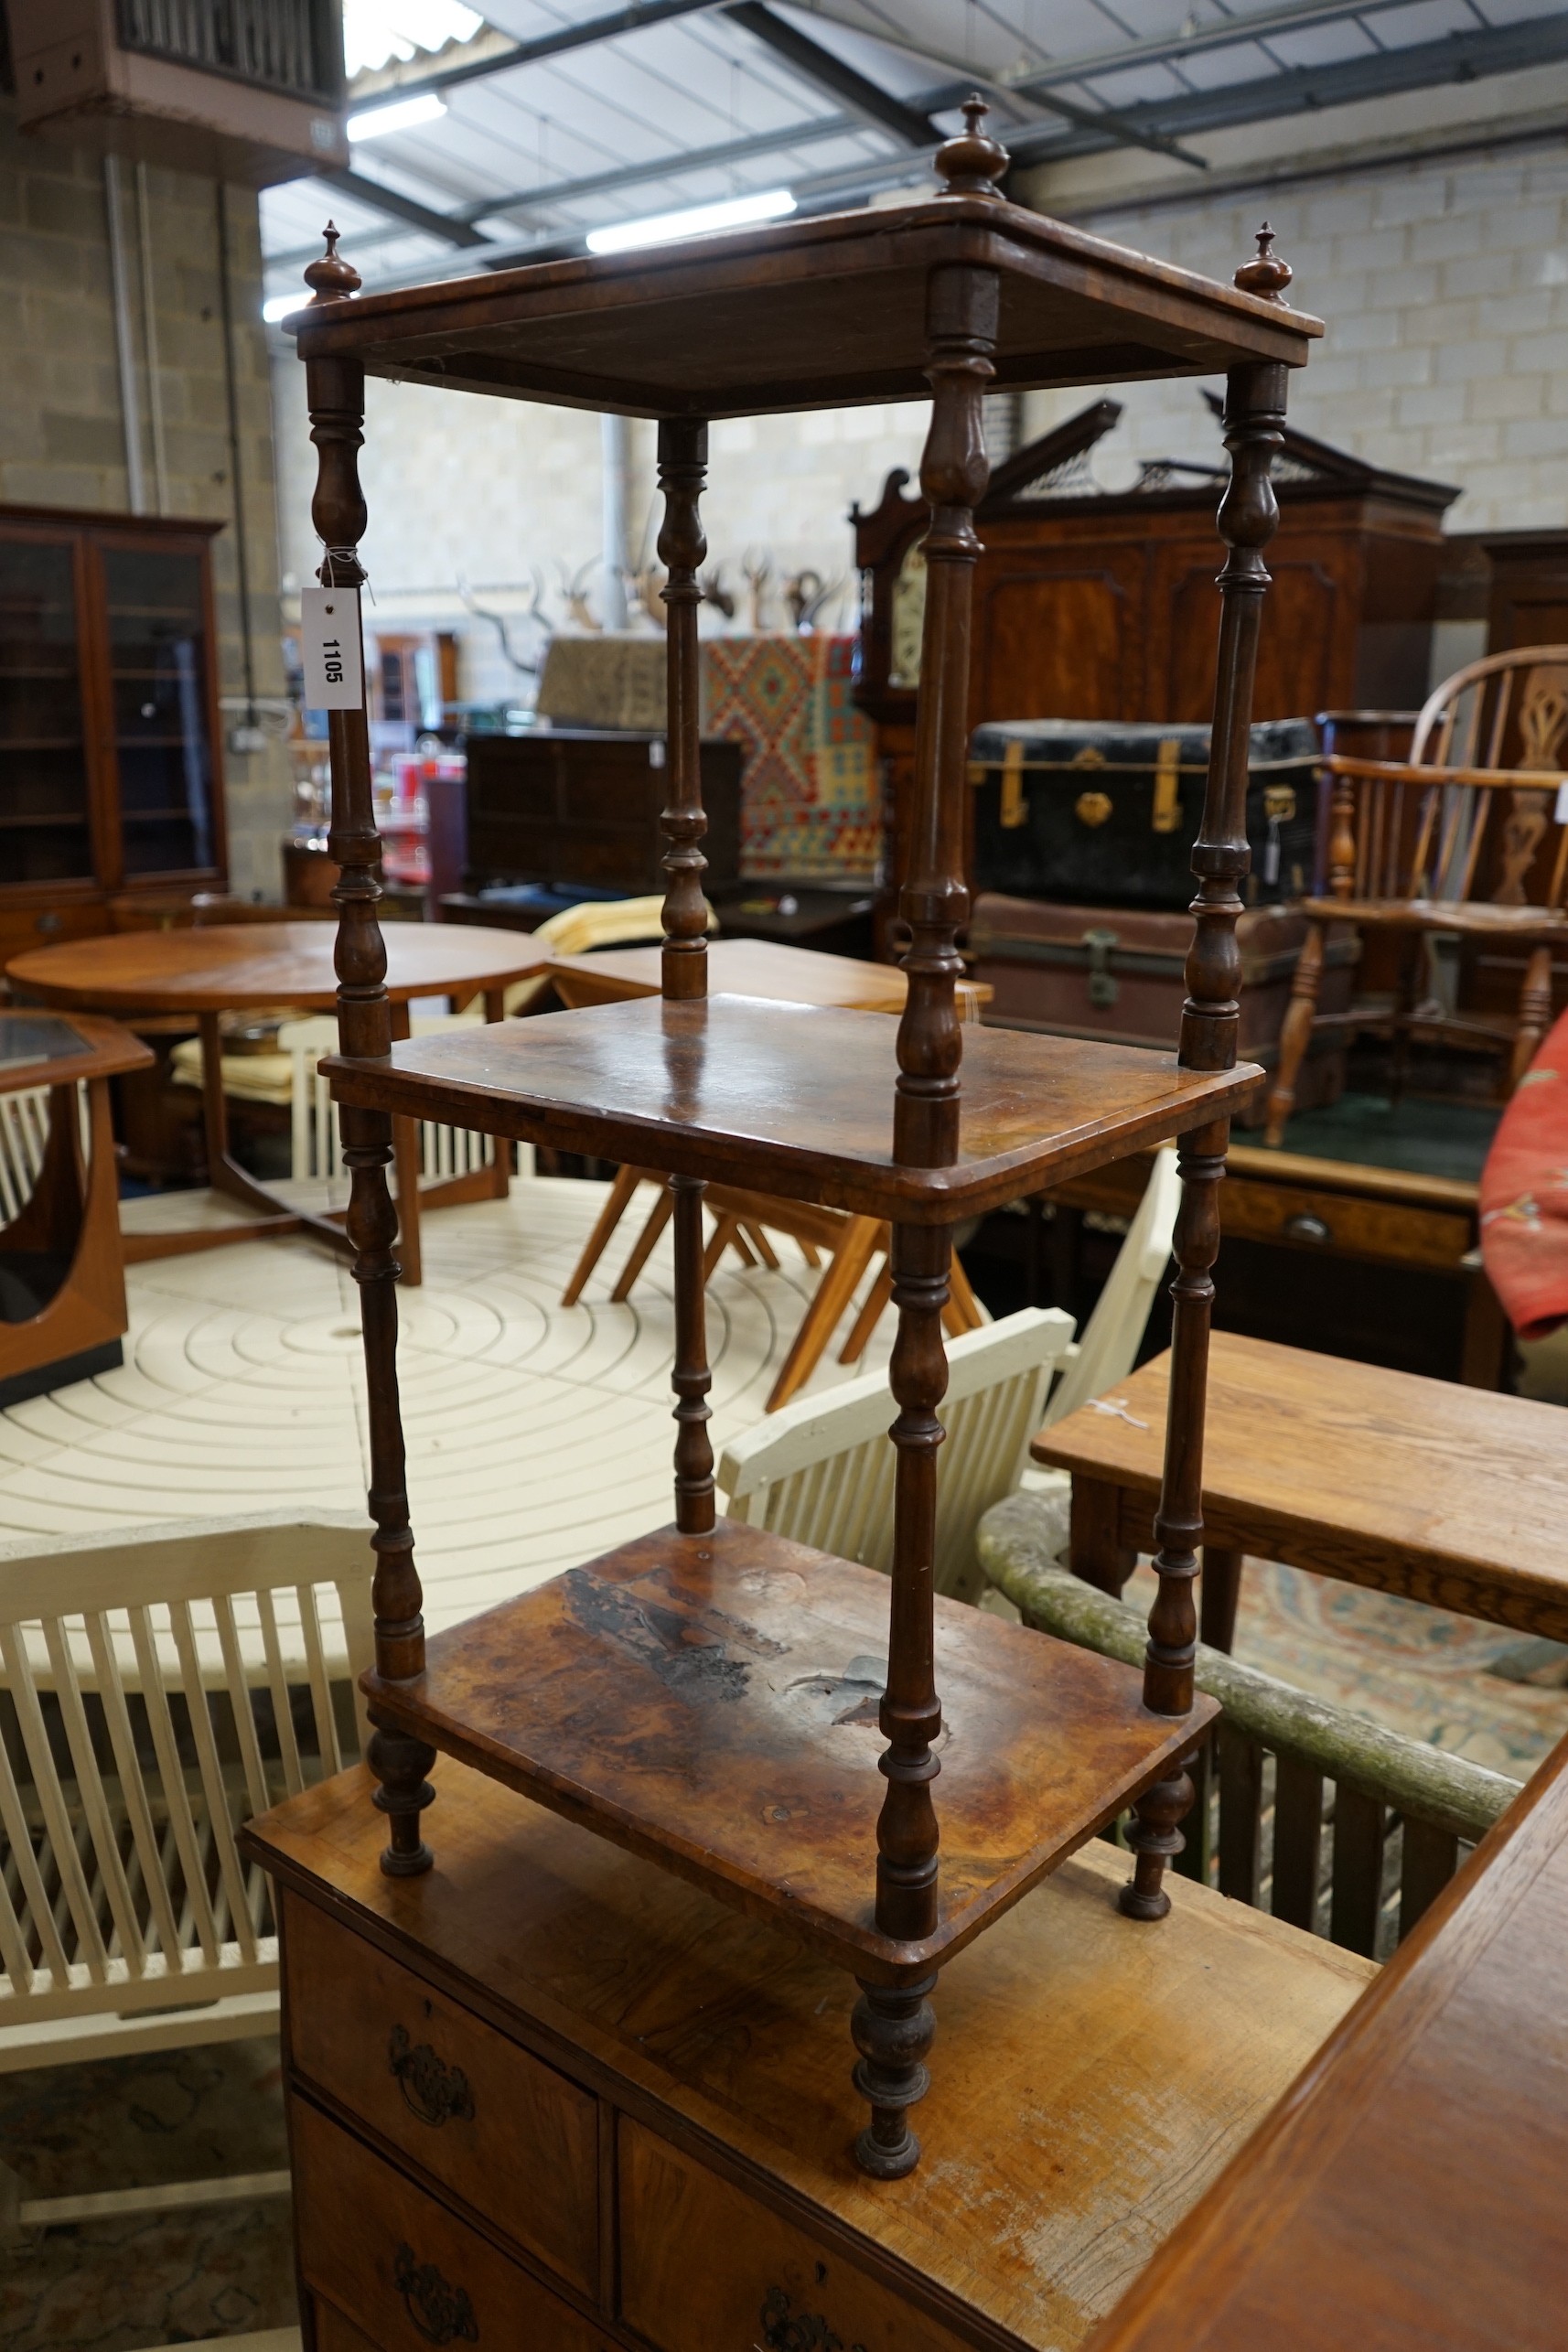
[292, 102, 1321, 2178]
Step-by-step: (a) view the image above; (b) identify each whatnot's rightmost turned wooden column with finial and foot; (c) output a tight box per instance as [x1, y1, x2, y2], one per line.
[1122, 223, 1291, 1919]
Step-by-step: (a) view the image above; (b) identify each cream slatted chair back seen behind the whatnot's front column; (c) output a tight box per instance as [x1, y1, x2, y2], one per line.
[719, 1307, 1072, 1602]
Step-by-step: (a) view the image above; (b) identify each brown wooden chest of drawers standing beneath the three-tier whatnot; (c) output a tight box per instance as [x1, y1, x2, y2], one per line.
[244, 1759, 1373, 2352]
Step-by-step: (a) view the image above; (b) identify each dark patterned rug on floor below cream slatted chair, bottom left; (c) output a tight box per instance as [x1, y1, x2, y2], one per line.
[0, 2039, 296, 2352]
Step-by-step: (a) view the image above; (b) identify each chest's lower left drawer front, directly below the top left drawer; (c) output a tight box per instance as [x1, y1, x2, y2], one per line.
[289, 2098, 614, 2352]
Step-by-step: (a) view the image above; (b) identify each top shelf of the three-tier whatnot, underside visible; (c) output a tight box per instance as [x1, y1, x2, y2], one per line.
[287, 193, 1324, 419]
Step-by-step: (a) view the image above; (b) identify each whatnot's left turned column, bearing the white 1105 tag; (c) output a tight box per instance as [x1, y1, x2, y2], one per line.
[306, 223, 435, 1877]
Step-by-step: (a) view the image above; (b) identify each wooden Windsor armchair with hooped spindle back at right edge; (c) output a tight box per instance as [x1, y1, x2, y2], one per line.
[1267, 644, 1568, 1145]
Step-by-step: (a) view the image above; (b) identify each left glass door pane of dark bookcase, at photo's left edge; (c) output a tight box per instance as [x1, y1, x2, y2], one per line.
[0, 539, 94, 882]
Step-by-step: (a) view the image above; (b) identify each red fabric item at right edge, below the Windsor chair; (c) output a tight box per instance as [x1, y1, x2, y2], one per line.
[1481, 1014, 1568, 1338]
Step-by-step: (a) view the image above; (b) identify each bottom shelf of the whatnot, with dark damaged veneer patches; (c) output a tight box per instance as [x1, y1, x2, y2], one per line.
[364, 1520, 1216, 1985]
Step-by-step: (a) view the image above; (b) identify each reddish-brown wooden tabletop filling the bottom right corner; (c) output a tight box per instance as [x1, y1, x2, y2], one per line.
[1093, 1743, 1568, 2352]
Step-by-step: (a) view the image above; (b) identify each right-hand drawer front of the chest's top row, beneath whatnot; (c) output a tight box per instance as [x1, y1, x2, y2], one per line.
[618, 2117, 961, 2352]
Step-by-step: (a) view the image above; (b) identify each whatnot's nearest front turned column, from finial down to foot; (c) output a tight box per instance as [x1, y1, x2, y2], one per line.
[854, 99, 1006, 2180]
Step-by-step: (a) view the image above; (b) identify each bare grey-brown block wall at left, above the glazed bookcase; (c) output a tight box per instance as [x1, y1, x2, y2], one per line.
[0, 99, 292, 898]
